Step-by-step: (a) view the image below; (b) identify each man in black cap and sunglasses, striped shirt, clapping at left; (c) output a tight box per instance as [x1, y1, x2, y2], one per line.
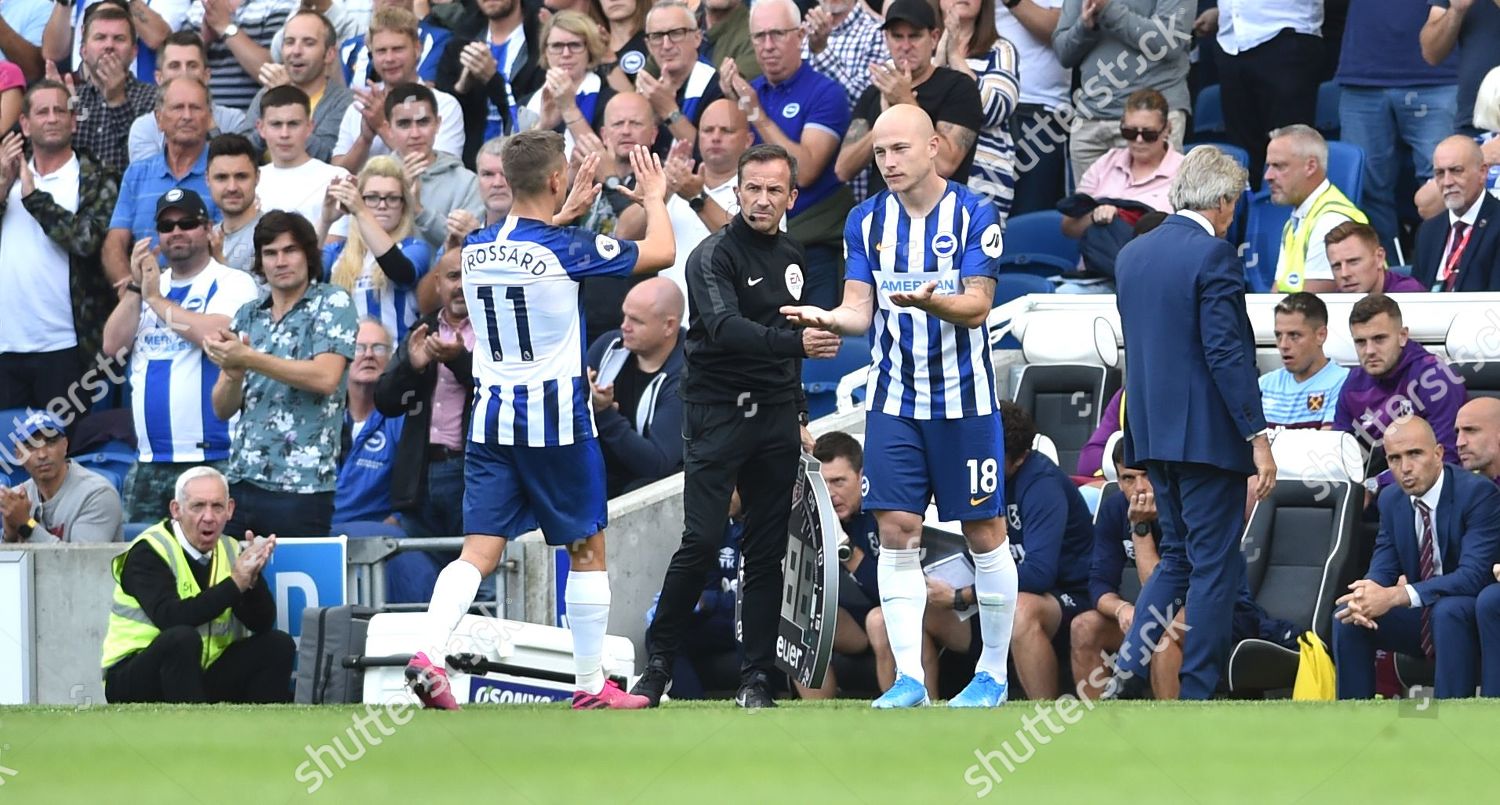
[104, 187, 257, 522]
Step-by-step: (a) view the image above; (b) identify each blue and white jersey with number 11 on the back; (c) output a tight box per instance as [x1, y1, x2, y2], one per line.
[462, 216, 639, 447]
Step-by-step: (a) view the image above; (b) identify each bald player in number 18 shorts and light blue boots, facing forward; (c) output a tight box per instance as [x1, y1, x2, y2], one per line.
[782, 103, 1017, 708]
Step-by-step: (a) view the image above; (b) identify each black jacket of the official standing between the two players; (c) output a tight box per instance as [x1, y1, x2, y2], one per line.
[683, 214, 807, 411]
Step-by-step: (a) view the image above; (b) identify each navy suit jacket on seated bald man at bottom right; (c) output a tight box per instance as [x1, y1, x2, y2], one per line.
[1365, 465, 1500, 607]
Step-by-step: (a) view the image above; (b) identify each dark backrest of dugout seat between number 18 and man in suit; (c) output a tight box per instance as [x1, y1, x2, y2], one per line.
[1016, 363, 1121, 474]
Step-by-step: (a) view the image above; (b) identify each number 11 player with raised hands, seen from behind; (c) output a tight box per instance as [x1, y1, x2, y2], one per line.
[407, 130, 675, 709]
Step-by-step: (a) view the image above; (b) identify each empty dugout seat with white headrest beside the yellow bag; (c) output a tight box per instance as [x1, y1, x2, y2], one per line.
[1226, 430, 1365, 696]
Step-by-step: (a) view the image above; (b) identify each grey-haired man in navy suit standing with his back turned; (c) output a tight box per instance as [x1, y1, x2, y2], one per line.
[1104, 145, 1277, 699]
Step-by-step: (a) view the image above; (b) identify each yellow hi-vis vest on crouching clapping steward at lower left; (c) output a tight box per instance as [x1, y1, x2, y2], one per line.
[101, 520, 245, 670]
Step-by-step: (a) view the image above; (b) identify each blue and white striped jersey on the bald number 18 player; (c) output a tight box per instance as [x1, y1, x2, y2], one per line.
[845, 181, 1004, 420]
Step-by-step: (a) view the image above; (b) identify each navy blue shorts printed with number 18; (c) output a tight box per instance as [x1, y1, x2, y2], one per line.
[864, 411, 1005, 520]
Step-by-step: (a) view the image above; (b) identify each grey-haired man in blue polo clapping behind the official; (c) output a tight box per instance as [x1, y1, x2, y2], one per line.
[720, 0, 852, 307]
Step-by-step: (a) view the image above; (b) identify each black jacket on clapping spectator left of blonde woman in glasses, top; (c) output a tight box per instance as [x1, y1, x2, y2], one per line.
[437, 0, 546, 165]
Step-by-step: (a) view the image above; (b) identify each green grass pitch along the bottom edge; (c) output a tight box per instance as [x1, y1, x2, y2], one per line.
[0, 700, 1500, 805]
